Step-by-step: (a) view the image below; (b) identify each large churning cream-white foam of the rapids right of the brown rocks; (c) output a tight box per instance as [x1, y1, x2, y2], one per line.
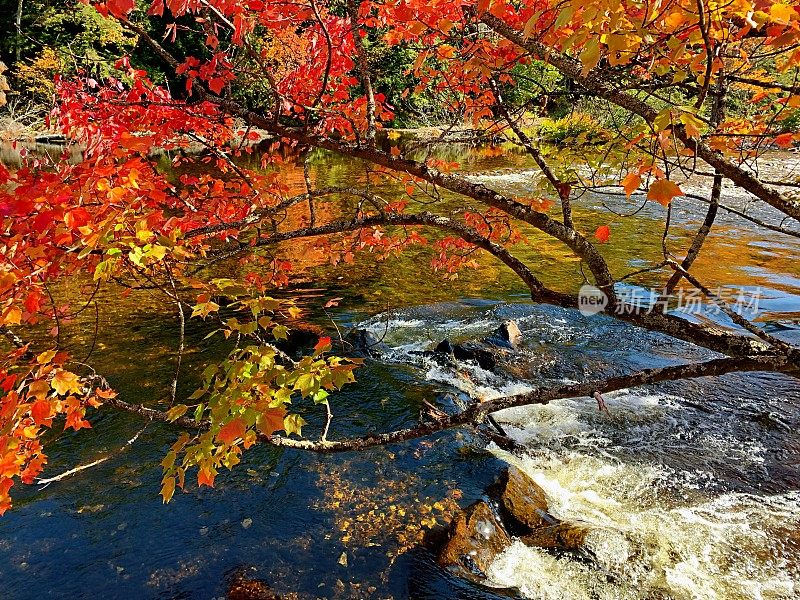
[482, 391, 800, 600]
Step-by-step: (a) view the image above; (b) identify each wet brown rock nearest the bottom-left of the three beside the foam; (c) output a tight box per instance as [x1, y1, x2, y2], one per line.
[438, 500, 511, 580]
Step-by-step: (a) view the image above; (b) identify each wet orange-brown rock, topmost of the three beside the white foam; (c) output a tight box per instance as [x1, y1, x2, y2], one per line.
[493, 466, 556, 532]
